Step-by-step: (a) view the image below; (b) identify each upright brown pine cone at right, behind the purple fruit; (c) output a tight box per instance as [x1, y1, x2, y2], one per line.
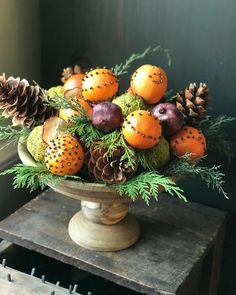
[176, 83, 210, 126]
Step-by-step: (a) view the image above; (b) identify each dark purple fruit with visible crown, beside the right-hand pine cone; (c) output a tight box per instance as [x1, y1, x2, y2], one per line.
[151, 102, 184, 137]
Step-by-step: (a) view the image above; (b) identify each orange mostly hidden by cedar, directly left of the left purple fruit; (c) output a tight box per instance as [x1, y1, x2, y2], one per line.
[59, 98, 93, 123]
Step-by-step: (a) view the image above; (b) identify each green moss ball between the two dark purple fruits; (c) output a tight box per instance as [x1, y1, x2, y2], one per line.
[112, 92, 147, 117]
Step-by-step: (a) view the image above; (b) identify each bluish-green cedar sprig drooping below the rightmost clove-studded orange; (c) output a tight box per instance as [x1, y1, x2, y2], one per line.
[162, 154, 228, 199]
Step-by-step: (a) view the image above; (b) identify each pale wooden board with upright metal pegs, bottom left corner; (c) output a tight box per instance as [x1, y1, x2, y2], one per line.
[0, 265, 81, 295]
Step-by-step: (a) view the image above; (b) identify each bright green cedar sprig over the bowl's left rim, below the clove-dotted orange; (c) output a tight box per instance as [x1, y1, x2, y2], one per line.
[0, 163, 82, 192]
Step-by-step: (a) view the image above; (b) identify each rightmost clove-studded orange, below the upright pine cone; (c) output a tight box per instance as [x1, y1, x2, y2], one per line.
[170, 126, 206, 161]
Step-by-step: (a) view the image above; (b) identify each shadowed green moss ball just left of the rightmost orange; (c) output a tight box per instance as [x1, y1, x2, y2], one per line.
[152, 136, 170, 170]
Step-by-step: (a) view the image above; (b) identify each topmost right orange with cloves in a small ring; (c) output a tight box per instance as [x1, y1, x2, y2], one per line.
[130, 65, 167, 104]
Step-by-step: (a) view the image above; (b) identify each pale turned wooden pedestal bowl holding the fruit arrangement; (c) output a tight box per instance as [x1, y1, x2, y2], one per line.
[18, 142, 140, 251]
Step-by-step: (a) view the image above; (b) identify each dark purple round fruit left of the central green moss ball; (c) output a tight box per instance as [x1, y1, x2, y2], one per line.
[92, 102, 123, 133]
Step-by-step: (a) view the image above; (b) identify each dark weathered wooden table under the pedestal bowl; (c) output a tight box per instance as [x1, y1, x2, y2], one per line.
[0, 189, 227, 295]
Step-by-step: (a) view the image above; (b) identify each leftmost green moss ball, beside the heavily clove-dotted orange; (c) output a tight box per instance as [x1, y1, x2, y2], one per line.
[27, 125, 46, 162]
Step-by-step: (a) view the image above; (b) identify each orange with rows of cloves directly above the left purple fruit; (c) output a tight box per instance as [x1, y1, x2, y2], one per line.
[82, 68, 119, 103]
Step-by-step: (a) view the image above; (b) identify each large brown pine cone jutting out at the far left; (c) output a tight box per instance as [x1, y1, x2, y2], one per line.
[0, 74, 56, 128]
